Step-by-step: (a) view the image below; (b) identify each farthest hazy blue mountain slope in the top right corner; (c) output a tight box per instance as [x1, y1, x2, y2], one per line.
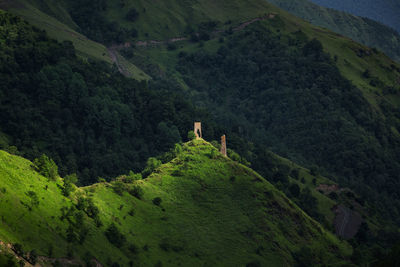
[311, 0, 400, 32]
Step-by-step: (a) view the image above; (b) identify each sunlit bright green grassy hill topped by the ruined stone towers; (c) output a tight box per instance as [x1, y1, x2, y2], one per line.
[0, 140, 351, 266]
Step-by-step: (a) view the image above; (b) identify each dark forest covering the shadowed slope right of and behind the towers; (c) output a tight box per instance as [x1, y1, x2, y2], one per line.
[176, 24, 400, 227]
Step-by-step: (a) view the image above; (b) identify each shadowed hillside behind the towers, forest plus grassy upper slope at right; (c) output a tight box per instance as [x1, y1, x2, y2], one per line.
[128, 13, 400, 229]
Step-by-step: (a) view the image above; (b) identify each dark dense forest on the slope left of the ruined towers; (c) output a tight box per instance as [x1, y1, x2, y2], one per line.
[0, 11, 202, 184]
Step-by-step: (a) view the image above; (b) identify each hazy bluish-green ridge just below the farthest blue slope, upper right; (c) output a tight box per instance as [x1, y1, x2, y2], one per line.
[268, 0, 400, 62]
